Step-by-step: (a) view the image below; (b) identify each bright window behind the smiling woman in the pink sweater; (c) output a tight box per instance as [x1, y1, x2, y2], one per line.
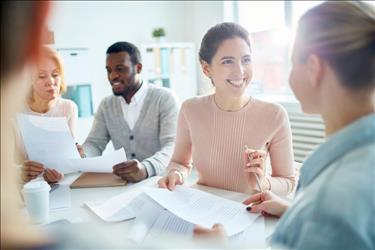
[235, 1, 322, 95]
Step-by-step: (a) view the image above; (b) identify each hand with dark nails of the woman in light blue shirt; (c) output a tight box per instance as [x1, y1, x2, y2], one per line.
[243, 191, 289, 217]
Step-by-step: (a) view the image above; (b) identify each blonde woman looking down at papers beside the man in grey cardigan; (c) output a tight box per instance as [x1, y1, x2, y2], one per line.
[21, 46, 78, 182]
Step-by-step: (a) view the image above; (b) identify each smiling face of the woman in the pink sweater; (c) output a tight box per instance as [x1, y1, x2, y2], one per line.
[203, 37, 253, 96]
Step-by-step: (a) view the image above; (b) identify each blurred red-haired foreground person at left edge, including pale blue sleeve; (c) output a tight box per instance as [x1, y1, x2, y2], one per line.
[1, 1, 129, 249]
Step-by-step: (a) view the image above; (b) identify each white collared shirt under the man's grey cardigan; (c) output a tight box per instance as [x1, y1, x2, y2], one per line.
[118, 82, 148, 130]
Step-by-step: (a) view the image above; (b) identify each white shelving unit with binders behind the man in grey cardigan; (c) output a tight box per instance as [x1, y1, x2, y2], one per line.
[141, 43, 198, 101]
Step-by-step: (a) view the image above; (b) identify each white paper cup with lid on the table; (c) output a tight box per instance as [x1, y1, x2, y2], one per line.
[22, 181, 51, 224]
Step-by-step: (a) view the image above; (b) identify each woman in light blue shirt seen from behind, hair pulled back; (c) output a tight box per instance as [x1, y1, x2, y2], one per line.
[195, 2, 375, 249]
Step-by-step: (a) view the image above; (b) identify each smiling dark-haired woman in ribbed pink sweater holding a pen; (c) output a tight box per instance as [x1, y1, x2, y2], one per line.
[159, 23, 295, 195]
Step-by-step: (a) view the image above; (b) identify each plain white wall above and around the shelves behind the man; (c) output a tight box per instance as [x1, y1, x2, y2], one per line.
[49, 1, 223, 143]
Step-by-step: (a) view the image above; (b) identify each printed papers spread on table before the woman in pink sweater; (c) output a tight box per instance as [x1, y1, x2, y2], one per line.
[86, 186, 266, 248]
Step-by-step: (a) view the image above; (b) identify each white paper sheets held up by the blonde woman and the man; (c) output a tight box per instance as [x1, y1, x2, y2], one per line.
[17, 114, 126, 173]
